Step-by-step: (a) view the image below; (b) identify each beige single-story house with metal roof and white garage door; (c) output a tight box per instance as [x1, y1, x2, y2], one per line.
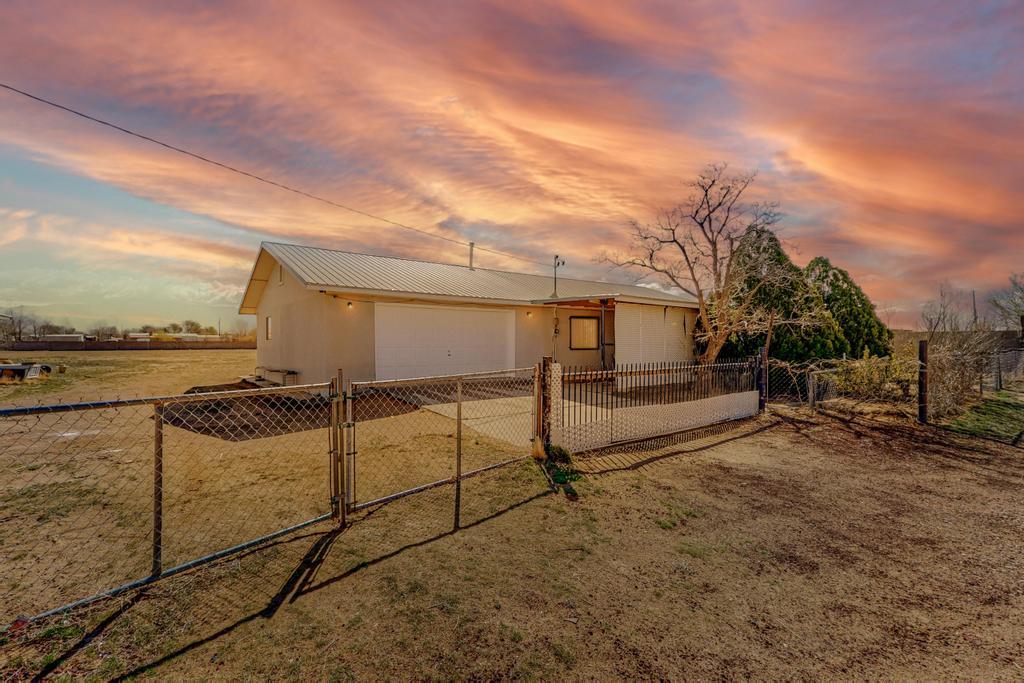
[239, 243, 696, 384]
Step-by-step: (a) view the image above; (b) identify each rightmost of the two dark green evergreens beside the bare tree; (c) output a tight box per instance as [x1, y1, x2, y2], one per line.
[804, 256, 893, 358]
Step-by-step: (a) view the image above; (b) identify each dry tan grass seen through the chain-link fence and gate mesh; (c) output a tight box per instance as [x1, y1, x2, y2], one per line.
[0, 400, 528, 624]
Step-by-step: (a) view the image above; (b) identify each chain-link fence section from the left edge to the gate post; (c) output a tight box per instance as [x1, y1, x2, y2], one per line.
[0, 384, 331, 624]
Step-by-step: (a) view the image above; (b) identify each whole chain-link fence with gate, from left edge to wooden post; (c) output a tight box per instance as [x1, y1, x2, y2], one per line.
[0, 368, 539, 626]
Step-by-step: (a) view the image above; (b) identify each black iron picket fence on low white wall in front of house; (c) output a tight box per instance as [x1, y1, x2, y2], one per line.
[551, 359, 759, 454]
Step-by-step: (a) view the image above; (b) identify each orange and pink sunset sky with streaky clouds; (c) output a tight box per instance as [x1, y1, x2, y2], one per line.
[0, 0, 1024, 328]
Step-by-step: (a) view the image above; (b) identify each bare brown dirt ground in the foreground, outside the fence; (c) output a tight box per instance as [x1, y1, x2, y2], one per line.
[0, 411, 1024, 680]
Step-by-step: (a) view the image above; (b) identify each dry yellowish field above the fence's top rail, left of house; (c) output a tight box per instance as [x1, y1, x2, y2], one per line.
[0, 349, 256, 407]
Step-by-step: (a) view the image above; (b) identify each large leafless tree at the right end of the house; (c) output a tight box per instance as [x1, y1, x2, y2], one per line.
[603, 164, 815, 362]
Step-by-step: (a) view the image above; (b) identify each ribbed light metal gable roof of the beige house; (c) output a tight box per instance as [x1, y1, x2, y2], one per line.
[240, 242, 694, 313]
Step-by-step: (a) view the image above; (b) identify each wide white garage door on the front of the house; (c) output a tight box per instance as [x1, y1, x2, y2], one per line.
[374, 303, 515, 380]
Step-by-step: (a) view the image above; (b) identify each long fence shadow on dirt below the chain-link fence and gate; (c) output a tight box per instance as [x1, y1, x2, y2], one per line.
[8, 462, 552, 680]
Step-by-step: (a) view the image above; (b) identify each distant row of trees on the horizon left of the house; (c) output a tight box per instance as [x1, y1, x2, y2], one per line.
[0, 307, 256, 342]
